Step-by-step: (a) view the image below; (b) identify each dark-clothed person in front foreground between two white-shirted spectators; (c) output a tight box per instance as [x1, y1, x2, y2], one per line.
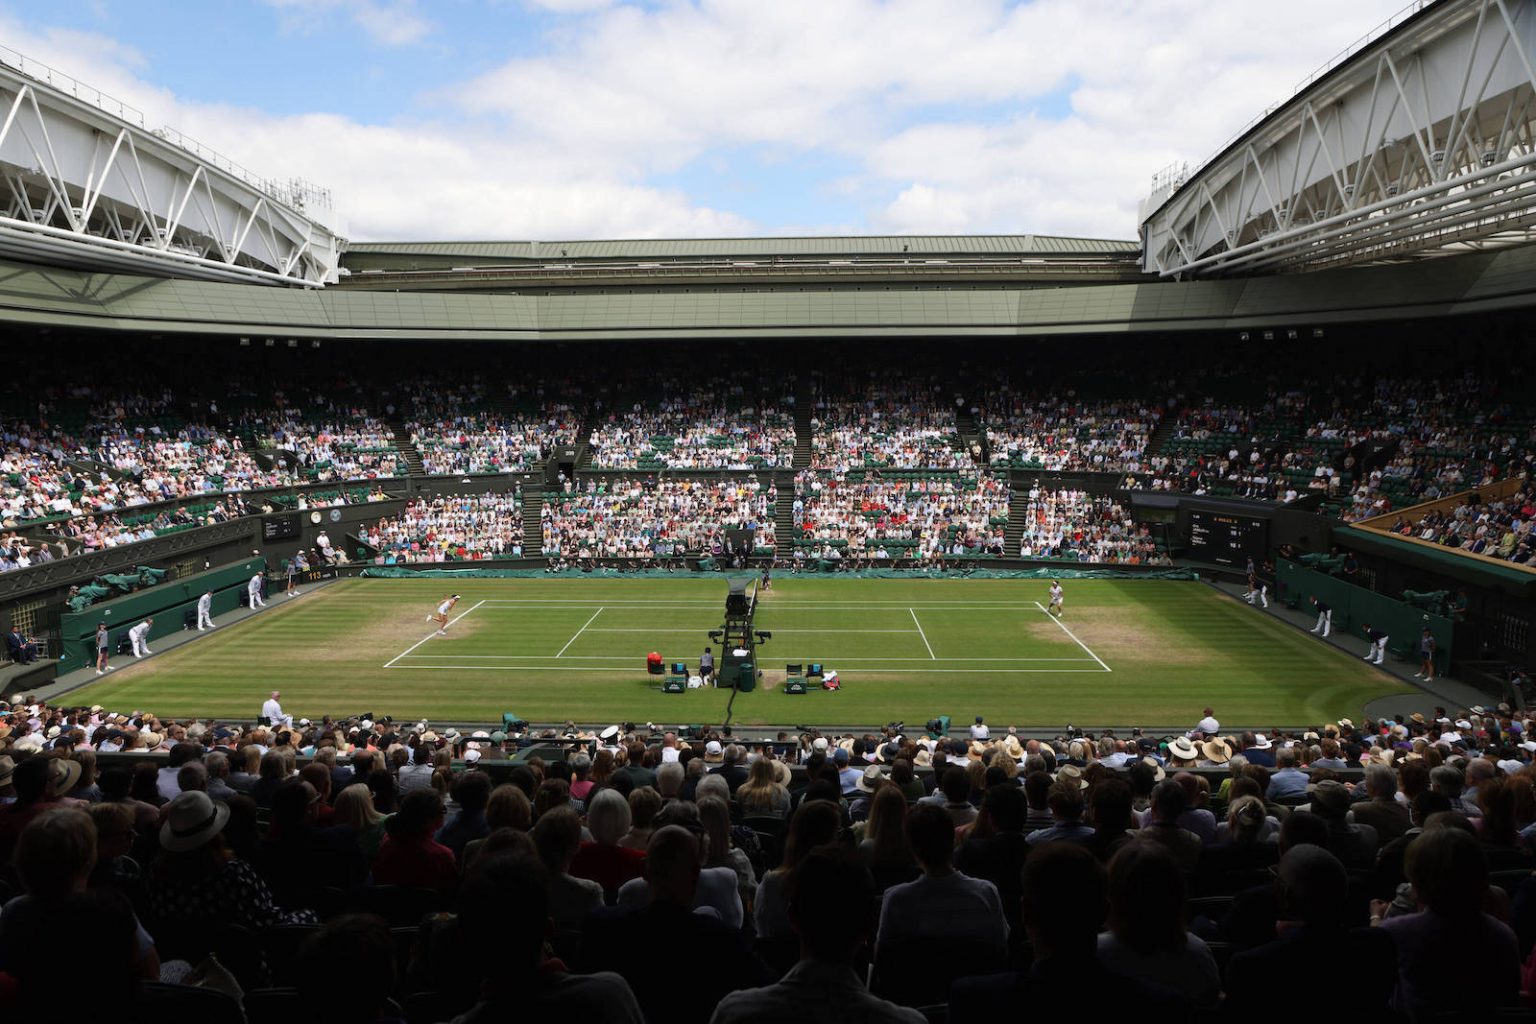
[949, 843, 1193, 1024]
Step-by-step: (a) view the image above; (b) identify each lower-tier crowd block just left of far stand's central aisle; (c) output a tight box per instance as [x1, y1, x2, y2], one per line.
[539, 476, 777, 559]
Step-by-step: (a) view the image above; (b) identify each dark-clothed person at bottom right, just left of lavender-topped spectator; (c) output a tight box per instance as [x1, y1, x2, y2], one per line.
[1227, 846, 1398, 1013]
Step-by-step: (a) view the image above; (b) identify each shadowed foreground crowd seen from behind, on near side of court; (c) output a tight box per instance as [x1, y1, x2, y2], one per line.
[0, 692, 1536, 1024]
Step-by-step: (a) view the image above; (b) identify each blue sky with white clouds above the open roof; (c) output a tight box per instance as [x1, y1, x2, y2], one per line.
[0, 0, 1402, 239]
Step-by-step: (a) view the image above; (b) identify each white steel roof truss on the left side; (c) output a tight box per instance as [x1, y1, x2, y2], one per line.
[0, 51, 346, 287]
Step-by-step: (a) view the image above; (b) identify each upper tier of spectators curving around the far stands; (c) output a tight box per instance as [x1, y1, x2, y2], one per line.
[0, 342, 1536, 571]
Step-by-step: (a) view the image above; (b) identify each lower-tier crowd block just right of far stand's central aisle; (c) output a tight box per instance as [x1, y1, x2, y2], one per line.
[794, 470, 1008, 560]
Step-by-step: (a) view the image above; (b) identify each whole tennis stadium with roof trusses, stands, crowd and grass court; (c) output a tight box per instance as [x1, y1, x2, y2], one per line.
[0, 0, 1536, 1024]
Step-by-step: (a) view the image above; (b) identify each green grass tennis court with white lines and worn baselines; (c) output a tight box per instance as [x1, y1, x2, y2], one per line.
[71, 577, 1405, 728]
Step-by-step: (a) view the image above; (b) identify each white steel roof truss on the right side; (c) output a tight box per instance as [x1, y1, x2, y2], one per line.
[1141, 0, 1536, 278]
